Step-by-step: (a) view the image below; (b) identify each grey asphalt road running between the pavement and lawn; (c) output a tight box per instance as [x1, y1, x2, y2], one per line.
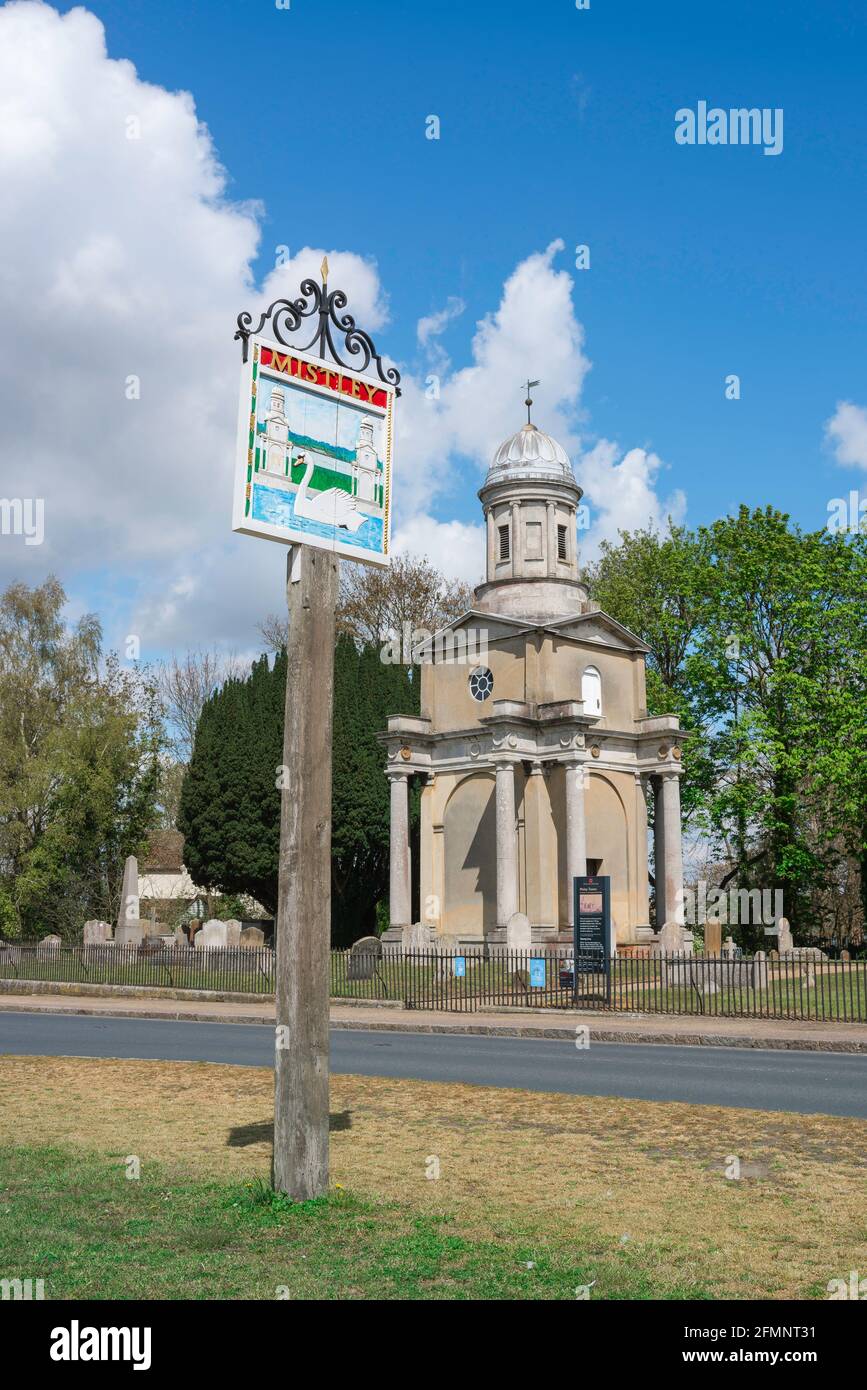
[0, 1012, 867, 1119]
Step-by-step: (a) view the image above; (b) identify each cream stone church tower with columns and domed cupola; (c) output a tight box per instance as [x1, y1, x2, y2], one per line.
[383, 397, 685, 947]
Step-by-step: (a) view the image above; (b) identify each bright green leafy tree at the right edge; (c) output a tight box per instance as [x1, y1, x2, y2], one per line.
[688, 507, 867, 945]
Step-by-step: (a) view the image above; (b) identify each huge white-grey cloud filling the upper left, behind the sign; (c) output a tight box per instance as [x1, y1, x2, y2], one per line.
[0, 3, 388, 651]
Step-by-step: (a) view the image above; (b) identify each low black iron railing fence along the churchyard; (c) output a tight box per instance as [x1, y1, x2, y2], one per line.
[0, 941, 867, 1023]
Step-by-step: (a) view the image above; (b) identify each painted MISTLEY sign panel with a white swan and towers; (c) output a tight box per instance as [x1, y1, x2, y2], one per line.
[232, 336, 395, 564]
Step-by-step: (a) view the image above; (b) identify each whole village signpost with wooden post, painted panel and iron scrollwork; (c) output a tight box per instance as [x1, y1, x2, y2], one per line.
[233, 260, 400, 1201]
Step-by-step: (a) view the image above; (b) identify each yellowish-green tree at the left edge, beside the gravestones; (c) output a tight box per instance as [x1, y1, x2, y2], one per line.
[0, 577, 161, 937]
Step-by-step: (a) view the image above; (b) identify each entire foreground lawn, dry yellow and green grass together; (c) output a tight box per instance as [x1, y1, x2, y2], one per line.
[0, 1049, 867, 1300]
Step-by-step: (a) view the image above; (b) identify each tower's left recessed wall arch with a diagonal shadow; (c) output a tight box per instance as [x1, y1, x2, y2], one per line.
[442, 771, 496, 938]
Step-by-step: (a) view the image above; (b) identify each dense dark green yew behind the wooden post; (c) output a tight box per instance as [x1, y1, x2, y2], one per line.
[178, 635, 420, 945]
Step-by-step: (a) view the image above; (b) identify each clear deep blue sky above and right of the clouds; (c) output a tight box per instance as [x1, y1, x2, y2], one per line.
[62, 0, 867, 536]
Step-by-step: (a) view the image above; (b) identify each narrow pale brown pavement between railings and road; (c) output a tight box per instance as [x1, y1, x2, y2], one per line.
[0, 991, 867, 1054]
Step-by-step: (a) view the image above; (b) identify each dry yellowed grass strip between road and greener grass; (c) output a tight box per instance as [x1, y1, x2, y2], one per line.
[0, 1056, 867, 1298]
